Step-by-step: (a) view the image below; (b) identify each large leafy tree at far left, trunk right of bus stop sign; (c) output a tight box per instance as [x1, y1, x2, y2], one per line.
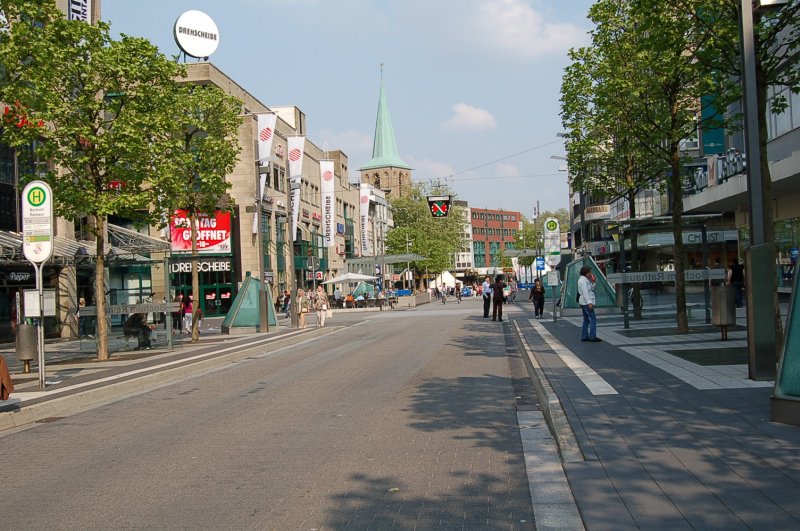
[0, 0, 182, 360]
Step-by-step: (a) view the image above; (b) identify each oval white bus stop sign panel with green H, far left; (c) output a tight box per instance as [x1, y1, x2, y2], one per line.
[22, 181, 53, 264]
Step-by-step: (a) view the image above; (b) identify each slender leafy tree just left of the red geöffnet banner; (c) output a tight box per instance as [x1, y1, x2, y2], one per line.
[158, 83, 242, 342]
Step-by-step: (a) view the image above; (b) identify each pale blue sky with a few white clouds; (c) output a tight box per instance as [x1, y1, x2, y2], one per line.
[102, 0, 592, 218]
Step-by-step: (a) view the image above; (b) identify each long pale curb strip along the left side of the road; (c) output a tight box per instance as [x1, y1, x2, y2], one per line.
[0, 327, 336, 435]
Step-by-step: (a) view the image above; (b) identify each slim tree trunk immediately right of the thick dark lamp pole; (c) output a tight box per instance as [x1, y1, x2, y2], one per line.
[748, 54, 783, 359]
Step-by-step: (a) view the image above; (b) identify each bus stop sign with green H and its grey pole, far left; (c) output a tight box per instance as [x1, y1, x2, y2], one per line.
[22, 181, 53, 389]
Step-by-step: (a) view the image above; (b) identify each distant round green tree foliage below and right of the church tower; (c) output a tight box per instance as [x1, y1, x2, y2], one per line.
[386, 186, 465, 275]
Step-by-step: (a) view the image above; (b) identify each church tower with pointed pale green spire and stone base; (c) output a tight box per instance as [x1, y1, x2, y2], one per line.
[358, 74, 412, 197]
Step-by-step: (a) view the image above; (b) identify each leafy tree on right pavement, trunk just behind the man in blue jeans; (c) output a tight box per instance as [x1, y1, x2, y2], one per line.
[567, 0, 712, 332]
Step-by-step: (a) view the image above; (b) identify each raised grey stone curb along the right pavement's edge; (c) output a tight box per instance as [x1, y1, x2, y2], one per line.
[512, 320, 586, 463]
